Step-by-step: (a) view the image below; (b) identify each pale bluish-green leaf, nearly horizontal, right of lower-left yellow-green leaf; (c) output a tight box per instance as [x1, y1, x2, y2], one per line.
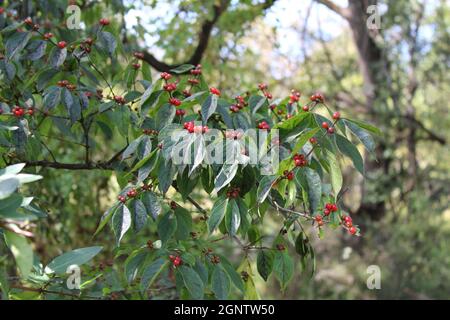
[46, 247, 103, 274]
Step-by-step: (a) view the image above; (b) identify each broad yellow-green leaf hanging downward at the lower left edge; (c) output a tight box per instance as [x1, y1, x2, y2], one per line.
[3, 230, 33, 279]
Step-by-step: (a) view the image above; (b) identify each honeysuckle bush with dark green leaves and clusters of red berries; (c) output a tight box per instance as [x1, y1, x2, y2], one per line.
[0, 11, 379, 299]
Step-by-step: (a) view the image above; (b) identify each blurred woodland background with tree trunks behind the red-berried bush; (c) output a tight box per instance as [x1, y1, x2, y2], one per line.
[18, 0, 450, 299]
